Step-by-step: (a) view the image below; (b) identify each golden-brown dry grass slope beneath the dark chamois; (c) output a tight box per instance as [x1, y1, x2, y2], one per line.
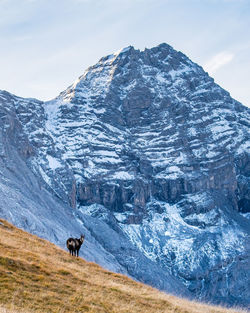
[0, 220, 246, 313]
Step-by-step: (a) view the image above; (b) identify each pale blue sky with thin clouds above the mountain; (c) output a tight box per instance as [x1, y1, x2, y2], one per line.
[0, 0, 250, 106]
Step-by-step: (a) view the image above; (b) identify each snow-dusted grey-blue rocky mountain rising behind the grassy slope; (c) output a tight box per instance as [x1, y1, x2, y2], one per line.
[0, 44, 250, 306]
